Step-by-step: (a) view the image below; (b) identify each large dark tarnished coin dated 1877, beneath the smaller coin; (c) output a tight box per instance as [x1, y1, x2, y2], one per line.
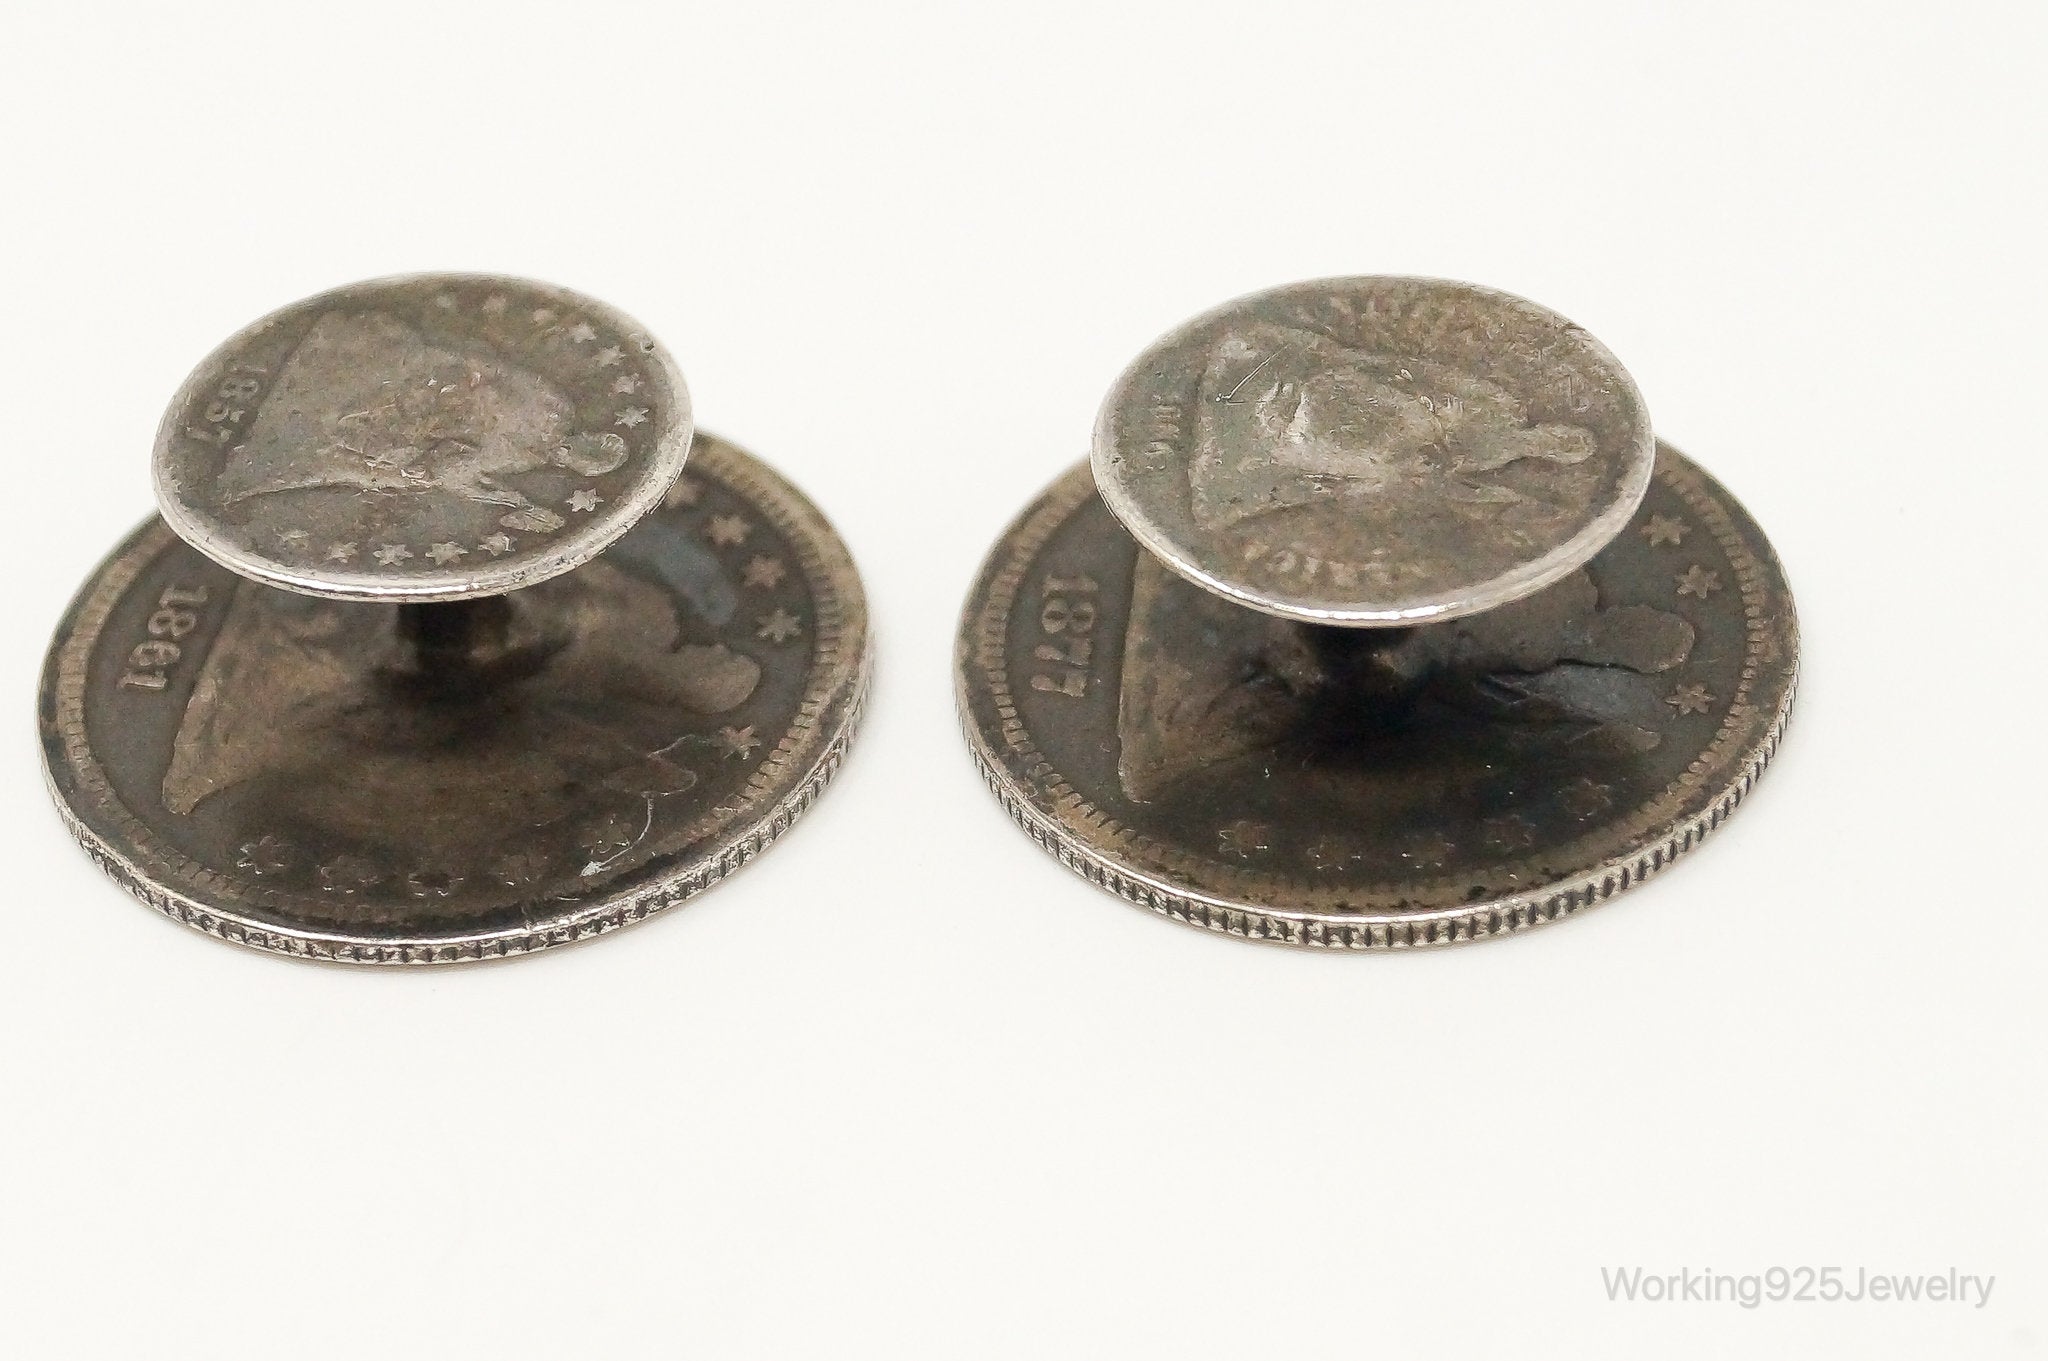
[956, 448, 1798, 950]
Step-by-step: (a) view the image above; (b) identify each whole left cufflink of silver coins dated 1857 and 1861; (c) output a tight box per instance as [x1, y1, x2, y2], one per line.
[41, 276, 866, 964]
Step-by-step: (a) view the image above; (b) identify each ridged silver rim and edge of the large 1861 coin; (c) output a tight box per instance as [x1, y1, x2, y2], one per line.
[39, 436, 872, 964]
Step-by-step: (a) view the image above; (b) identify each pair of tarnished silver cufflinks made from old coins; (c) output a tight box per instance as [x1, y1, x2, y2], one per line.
[39, 274, 1798, 964]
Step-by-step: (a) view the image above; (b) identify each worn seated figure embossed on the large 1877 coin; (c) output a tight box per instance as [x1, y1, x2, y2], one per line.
[1116, 555, 1696, 804]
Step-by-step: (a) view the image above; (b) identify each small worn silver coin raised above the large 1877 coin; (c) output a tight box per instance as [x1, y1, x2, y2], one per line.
[1094, 276, 1655, 626]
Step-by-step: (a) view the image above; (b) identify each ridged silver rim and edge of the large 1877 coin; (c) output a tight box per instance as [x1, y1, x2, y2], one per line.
[954, 450, 1798, 950]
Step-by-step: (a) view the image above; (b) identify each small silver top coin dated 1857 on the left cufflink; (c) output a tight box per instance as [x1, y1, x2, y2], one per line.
[154, 274, 690, 600]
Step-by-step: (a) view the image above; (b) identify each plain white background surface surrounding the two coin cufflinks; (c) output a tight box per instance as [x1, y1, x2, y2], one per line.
[0, 0, 2048, 1361]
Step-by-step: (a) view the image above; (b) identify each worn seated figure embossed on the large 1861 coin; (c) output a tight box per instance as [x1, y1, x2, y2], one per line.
[162, 524, 762, 866]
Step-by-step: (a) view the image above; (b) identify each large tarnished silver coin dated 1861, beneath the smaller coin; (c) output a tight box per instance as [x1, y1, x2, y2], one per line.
[39, 429, 868, 964]
